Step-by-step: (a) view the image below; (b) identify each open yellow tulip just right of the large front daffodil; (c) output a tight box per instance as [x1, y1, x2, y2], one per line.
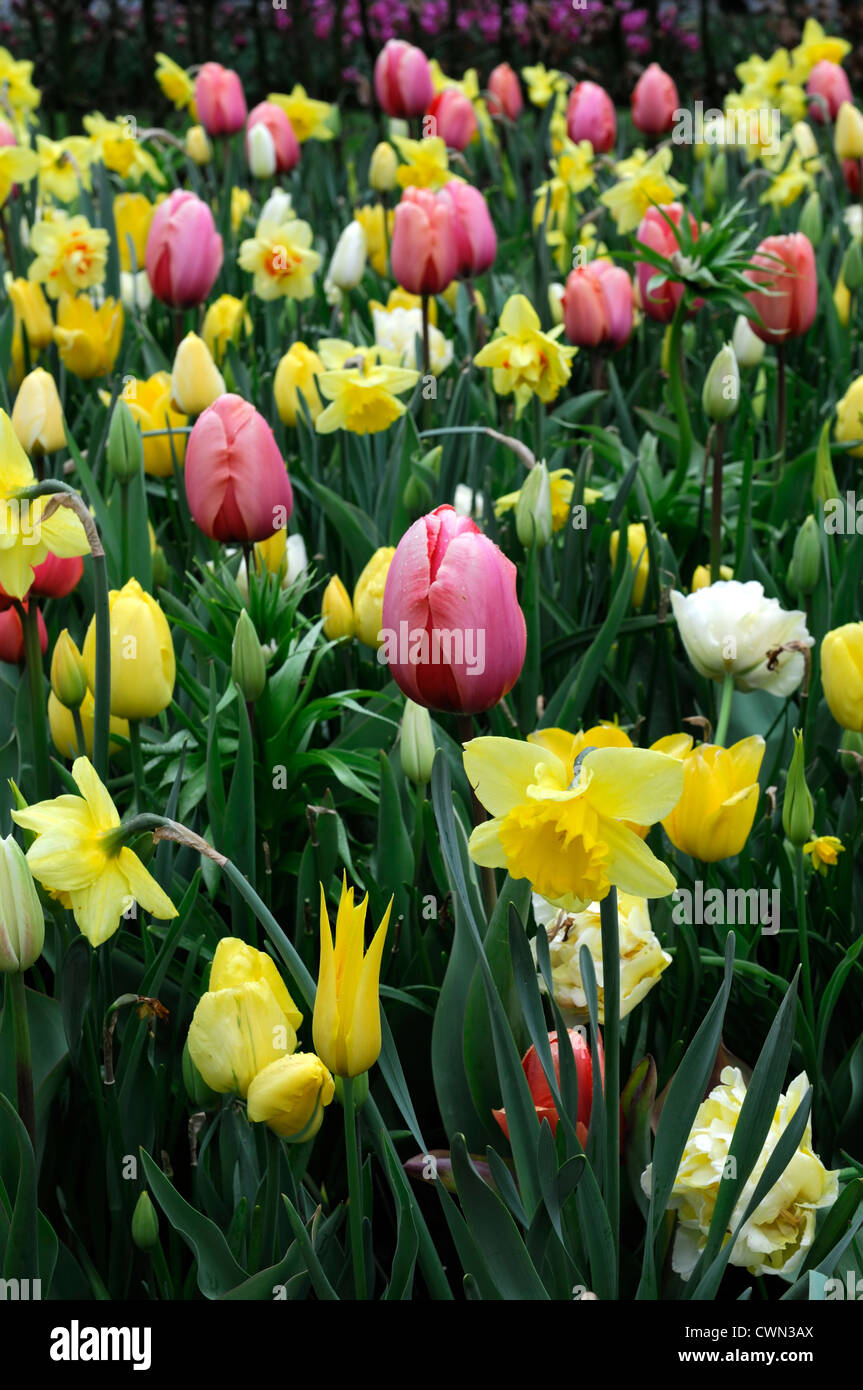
[655, 734, 764, 863]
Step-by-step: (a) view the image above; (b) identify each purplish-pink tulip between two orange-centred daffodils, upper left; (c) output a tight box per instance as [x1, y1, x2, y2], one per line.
[146, 189, 222, 309]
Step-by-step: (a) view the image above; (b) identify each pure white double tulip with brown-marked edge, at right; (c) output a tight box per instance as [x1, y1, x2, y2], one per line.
[671, 580, 814, 698]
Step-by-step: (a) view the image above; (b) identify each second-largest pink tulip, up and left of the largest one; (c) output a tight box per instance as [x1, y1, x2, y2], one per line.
[183, 395, 293, 545]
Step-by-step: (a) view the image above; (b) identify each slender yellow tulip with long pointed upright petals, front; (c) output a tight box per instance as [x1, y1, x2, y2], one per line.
[313, 881, 392, 1076]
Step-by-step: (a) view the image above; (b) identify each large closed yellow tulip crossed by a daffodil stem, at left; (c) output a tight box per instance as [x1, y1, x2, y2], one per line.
[83, 580, 176, 719]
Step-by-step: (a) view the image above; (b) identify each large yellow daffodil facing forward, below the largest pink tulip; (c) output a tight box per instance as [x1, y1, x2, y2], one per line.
[464, 738, 684, 910]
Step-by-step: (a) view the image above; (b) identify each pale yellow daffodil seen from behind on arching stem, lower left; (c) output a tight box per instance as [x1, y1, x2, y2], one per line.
[13, 758, 176, 947]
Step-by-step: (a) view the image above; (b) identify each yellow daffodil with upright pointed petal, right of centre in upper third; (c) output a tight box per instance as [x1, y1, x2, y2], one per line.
[474, 295, 577, 416]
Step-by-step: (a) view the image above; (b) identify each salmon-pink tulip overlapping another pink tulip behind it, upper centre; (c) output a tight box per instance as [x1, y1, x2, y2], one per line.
[391, 186, 459, 295]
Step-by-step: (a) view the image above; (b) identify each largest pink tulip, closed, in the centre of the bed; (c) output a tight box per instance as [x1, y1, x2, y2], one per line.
[378, 506, 527, 714]
